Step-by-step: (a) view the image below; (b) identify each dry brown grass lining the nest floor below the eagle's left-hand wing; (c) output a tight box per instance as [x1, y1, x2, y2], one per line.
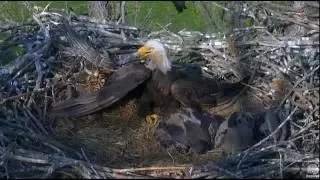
[55, 93, 226, 168]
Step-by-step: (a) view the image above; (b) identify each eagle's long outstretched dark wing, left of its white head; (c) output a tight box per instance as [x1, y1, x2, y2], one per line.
[50, 64, 151, 117]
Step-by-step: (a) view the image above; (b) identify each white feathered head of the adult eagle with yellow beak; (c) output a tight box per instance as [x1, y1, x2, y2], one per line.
[138, 40, 171, 74]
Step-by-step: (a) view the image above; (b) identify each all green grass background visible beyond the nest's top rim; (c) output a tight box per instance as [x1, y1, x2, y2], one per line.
[0, 1, 286, 66]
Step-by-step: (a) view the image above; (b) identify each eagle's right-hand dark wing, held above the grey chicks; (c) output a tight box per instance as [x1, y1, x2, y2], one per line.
[170, 68, 250, 107]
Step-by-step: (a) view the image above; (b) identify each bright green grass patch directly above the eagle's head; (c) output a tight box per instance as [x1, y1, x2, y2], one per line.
[126, 1, 208, 32]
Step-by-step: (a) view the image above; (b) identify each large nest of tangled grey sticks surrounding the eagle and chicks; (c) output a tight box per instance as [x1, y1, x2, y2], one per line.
[0, 3, 320, 178]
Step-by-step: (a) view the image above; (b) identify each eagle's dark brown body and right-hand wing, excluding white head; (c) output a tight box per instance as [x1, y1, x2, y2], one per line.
[139, 65, 249, 116]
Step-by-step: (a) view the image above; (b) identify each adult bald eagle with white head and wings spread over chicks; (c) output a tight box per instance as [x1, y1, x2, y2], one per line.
[50, 40, 249, 117]
